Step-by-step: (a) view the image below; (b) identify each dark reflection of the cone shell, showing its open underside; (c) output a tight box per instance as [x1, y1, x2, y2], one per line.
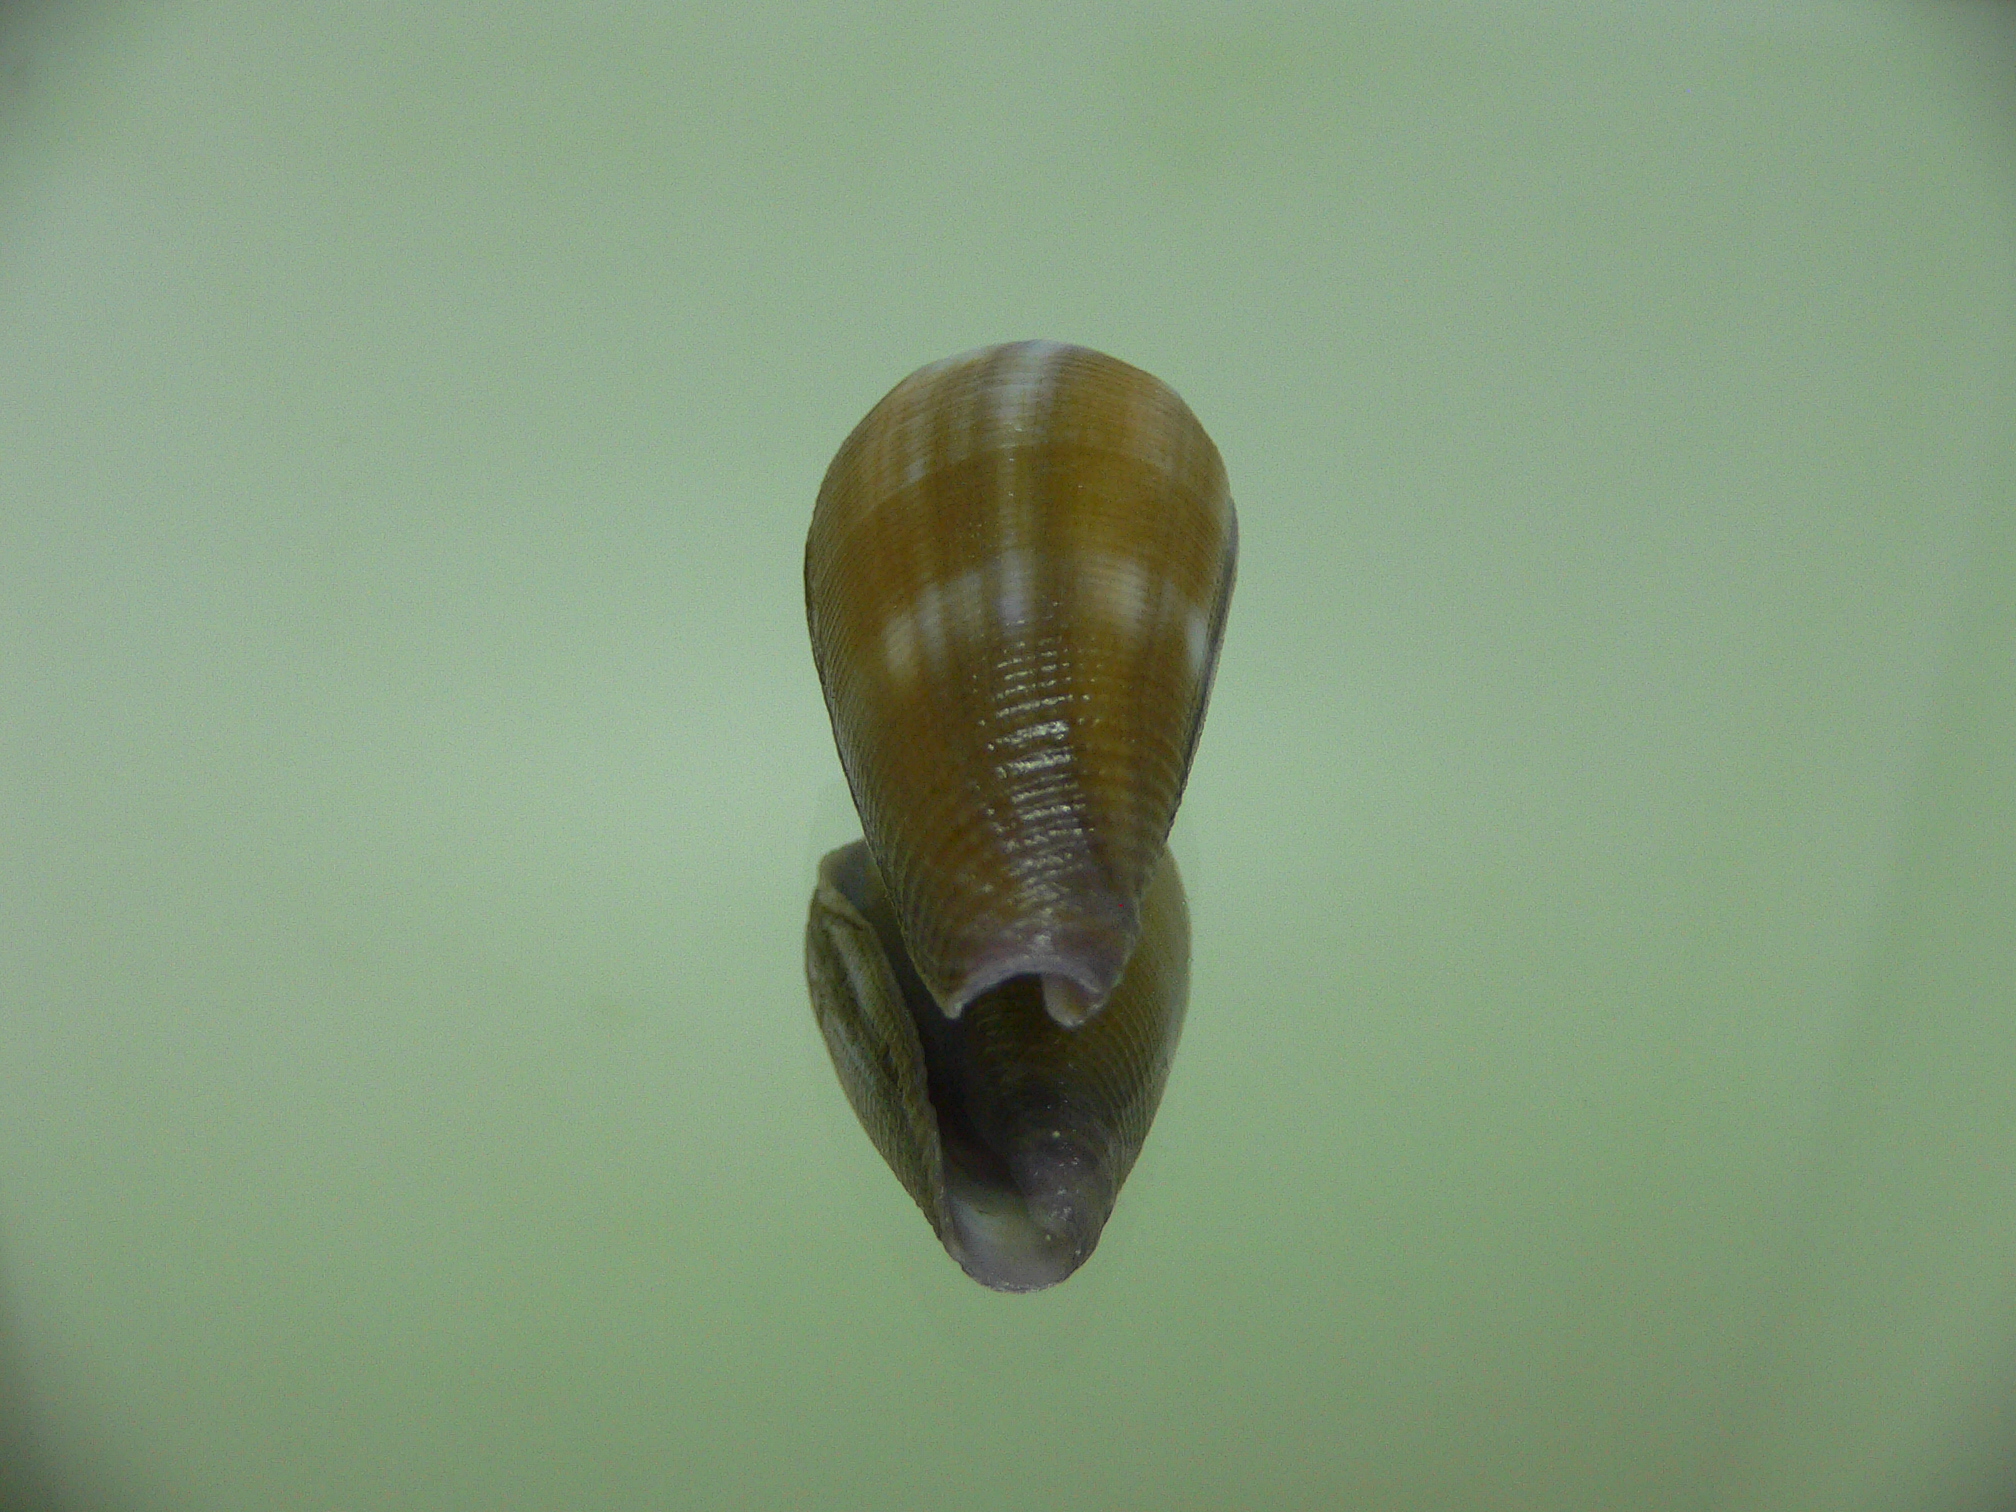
[804, 841, 1189, 1292]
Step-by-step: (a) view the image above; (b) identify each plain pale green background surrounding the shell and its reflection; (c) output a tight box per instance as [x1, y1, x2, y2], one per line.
[0, 2, 2016, 1512]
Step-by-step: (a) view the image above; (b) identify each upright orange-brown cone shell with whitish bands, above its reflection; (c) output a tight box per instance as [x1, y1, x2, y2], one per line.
[804, 343, 1238, 1024]
